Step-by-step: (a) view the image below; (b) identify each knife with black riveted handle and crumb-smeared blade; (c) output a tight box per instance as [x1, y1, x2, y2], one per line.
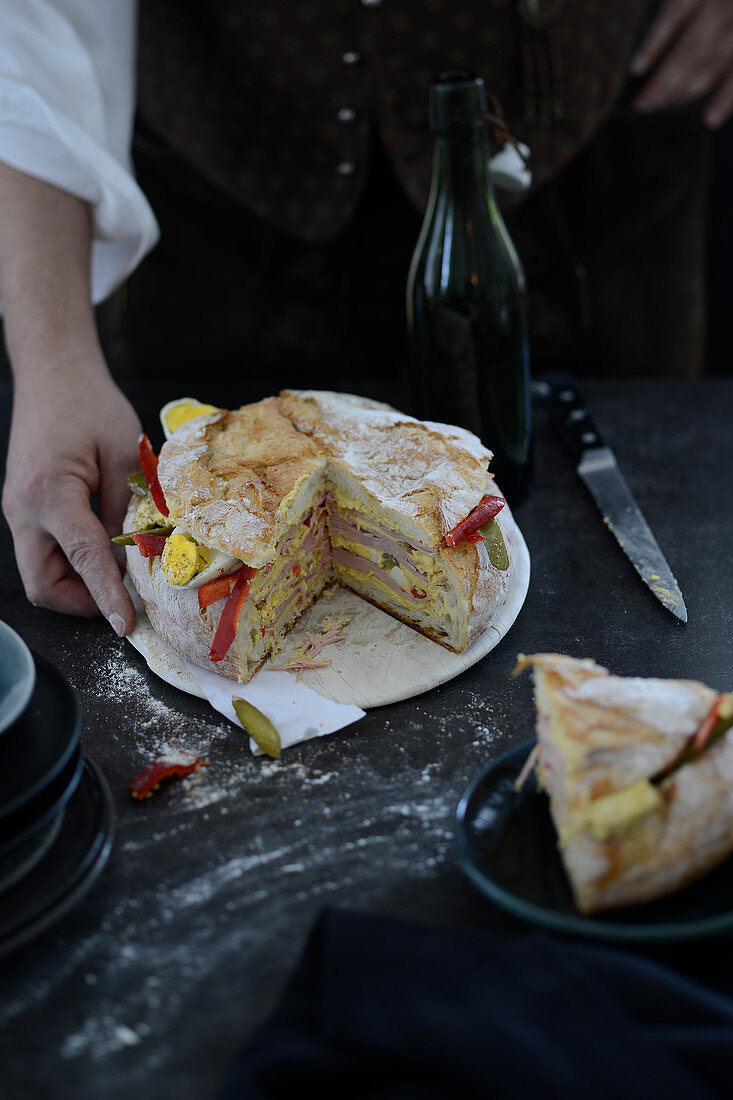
[532, 375, 687, 623]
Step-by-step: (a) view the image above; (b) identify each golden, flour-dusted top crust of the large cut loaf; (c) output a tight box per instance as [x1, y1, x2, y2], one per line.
[157, 391, 492, 568]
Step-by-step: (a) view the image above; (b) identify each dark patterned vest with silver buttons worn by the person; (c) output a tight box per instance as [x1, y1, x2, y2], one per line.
[139, 0, 649, 240]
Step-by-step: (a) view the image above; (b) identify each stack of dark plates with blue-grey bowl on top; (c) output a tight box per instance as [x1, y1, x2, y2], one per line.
[0, 622, 114, 956]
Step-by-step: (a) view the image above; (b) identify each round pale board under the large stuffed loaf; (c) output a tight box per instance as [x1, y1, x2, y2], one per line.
[125, 528, 529, 708]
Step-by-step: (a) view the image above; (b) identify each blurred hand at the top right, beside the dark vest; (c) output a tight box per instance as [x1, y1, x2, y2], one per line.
[630, 0, 733, 130]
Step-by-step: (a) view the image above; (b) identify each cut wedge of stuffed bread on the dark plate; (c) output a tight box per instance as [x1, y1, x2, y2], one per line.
[517, 653, 733, 913]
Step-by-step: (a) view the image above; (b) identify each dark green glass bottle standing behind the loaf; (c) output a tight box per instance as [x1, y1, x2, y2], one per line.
[407, 70, 532, 503]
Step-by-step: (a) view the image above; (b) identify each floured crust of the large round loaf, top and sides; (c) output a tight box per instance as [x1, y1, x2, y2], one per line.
[124, 391, 515, 680]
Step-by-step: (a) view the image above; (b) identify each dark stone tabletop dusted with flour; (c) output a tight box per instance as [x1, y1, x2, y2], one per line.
[0, 380, 733, 1100]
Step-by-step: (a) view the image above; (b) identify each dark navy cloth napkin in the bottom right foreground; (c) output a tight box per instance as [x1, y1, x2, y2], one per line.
[220, 909, 733, 1100]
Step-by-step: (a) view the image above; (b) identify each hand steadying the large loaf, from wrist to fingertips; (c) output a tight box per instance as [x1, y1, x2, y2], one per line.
[2, 363, 141, 635]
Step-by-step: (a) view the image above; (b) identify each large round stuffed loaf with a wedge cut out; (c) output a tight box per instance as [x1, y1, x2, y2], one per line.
[119, 391, 515, 681]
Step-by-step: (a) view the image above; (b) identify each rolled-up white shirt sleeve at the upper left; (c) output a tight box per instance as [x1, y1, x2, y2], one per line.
[0, 0, 158, 303]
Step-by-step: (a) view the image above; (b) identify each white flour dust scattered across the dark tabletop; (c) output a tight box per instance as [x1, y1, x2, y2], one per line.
[8, 648, 499, 1085]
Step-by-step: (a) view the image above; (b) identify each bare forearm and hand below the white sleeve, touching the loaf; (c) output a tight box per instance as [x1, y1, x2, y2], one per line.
[0, 163, 140, 634]
